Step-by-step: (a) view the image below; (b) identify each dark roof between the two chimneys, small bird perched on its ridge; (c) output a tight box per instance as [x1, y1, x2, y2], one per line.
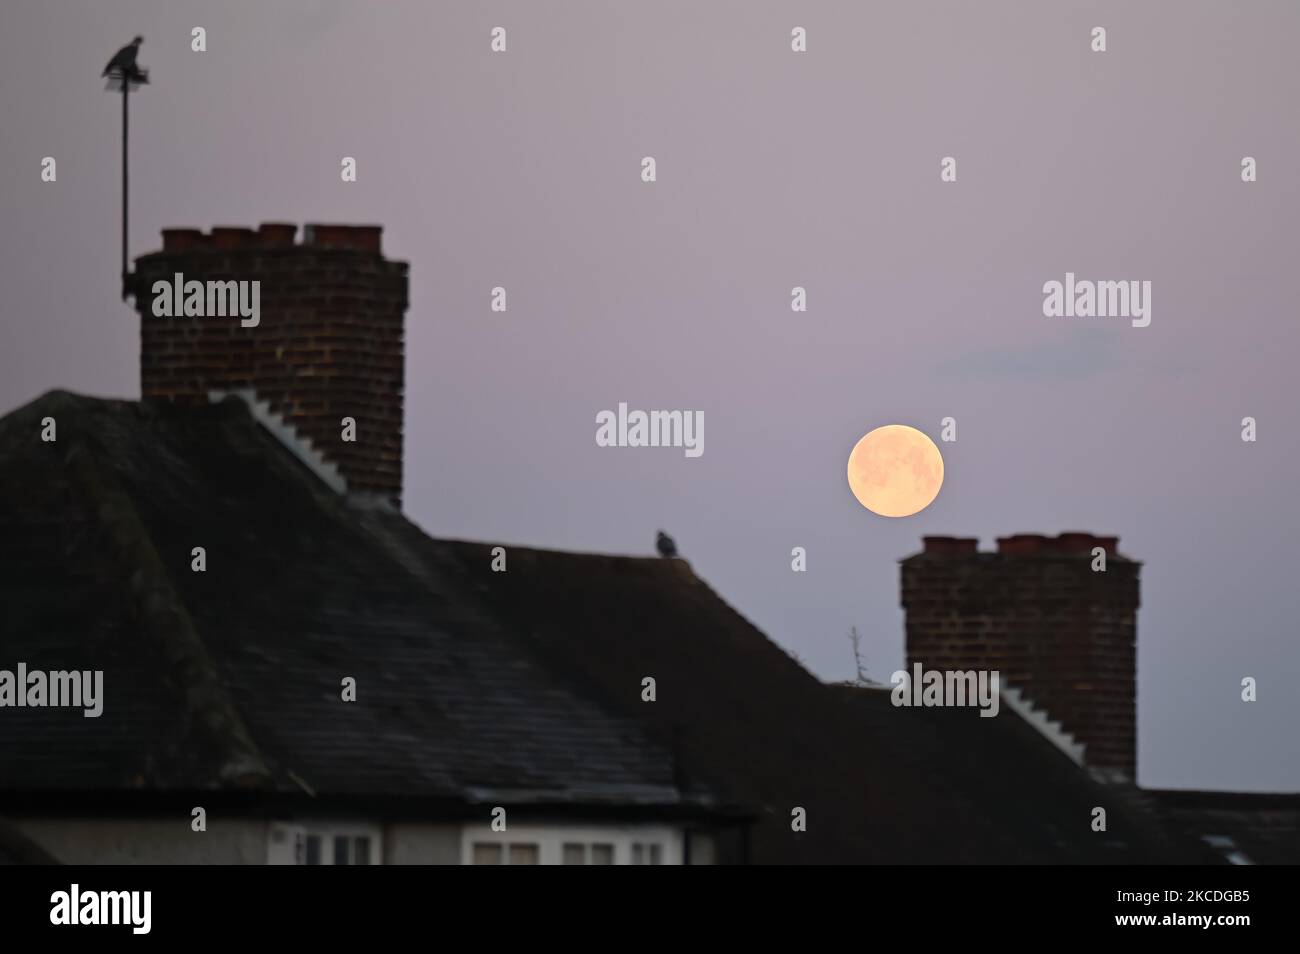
[421, 537, 1210, 863]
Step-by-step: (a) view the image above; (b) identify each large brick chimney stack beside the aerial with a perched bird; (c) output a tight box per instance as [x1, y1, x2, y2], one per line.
[134, 224, 407, 506]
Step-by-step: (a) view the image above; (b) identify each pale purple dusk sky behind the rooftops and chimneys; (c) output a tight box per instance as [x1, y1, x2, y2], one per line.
[0, 0, 1300, 790]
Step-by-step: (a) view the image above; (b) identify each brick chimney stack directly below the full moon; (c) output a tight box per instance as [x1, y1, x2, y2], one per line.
[902, 533, 1141, 779]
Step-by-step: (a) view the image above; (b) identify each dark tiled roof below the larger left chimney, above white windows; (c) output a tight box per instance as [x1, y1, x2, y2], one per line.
[0, 393, 698, 806]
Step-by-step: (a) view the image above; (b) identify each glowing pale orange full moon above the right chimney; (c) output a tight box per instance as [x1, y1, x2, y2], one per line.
[849, 424, 944, 517]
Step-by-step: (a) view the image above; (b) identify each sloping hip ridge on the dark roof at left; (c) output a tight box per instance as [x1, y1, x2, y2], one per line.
[64, 428, 270, 786]
